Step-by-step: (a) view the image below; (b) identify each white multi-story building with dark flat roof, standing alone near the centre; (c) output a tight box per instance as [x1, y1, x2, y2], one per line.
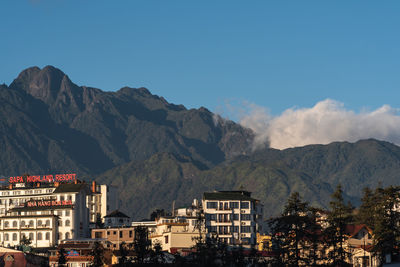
[202, 191, 262, 246]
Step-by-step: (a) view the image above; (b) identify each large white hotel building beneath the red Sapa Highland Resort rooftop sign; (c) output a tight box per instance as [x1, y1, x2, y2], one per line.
[0, 180, 118, 248]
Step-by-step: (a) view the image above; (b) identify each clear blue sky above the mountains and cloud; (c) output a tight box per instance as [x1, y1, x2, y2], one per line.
[0, 0, 400, 118]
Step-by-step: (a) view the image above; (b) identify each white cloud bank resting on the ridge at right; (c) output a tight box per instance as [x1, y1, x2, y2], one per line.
[236, 99, 400, 149]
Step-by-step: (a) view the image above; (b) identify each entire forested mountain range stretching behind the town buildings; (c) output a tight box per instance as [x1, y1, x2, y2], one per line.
[0, 66, 400, 219]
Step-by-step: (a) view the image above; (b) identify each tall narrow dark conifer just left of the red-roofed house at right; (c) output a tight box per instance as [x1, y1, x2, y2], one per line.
[324, 184, 353, 266]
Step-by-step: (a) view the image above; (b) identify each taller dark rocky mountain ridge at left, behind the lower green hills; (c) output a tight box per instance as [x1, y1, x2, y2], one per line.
[0, 66, 253, 176]
